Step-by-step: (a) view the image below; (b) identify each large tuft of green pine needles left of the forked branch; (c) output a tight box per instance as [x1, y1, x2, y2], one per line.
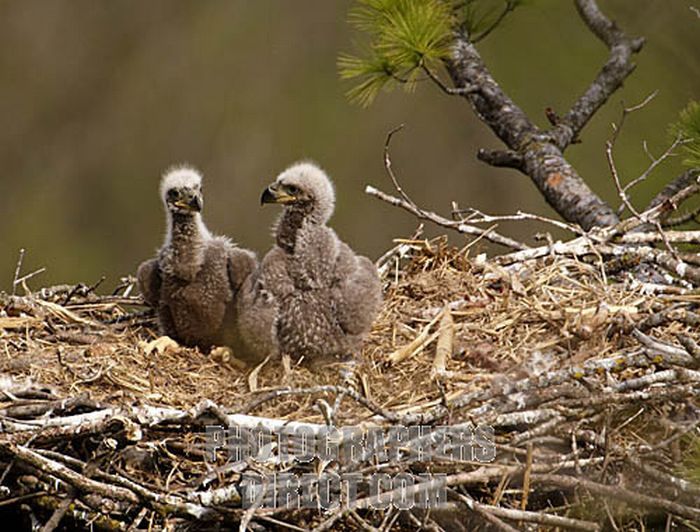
[338, 0, 453, 107]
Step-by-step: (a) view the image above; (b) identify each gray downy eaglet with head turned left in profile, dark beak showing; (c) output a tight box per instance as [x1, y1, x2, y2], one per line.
[238, 162, 382, 363]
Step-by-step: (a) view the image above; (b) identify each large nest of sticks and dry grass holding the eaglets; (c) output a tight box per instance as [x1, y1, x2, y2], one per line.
[0, 238, 700, 530]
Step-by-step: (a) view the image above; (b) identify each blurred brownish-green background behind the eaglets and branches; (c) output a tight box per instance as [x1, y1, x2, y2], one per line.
[0, 0, 700, 290]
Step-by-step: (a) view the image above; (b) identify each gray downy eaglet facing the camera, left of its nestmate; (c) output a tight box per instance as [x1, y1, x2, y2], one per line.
[137, 166, 257, 352]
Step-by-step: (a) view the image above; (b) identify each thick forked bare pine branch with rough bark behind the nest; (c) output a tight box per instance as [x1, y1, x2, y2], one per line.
[446, 0, 644, 230]
